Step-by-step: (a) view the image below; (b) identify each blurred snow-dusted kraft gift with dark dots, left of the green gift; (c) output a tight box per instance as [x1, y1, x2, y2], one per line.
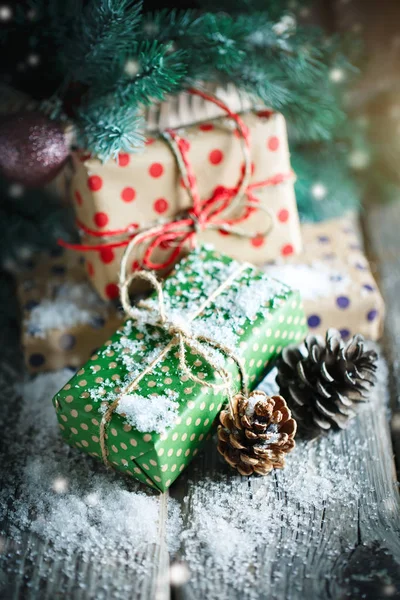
[17, 248, 121, 373]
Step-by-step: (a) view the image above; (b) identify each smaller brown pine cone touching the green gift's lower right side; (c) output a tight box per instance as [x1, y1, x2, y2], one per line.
[218, 391, 297, 475]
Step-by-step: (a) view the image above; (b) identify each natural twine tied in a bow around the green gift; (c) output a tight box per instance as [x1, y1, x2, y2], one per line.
[99, 232, 248, 465]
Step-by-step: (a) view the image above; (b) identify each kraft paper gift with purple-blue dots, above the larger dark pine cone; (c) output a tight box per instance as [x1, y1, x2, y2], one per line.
[265, 216, 384, 340]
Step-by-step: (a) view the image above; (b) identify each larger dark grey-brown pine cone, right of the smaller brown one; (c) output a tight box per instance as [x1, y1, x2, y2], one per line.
[276, 329, 377, 437]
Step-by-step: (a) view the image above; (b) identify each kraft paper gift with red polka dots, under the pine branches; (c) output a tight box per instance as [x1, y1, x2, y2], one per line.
[71, 102, 301, 298]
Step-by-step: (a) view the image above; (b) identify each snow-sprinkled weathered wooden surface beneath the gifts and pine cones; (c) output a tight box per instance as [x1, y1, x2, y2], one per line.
[0, 208, 400, 600]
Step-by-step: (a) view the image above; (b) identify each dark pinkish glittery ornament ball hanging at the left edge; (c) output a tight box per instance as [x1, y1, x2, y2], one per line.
[0, 111, 69, 187]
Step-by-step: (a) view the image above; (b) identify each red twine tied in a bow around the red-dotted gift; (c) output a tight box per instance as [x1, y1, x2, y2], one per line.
[59, 89, 293, 270]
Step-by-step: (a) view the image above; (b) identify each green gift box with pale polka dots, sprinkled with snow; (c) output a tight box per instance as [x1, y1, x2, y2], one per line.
[53, 246, 306, 491]
